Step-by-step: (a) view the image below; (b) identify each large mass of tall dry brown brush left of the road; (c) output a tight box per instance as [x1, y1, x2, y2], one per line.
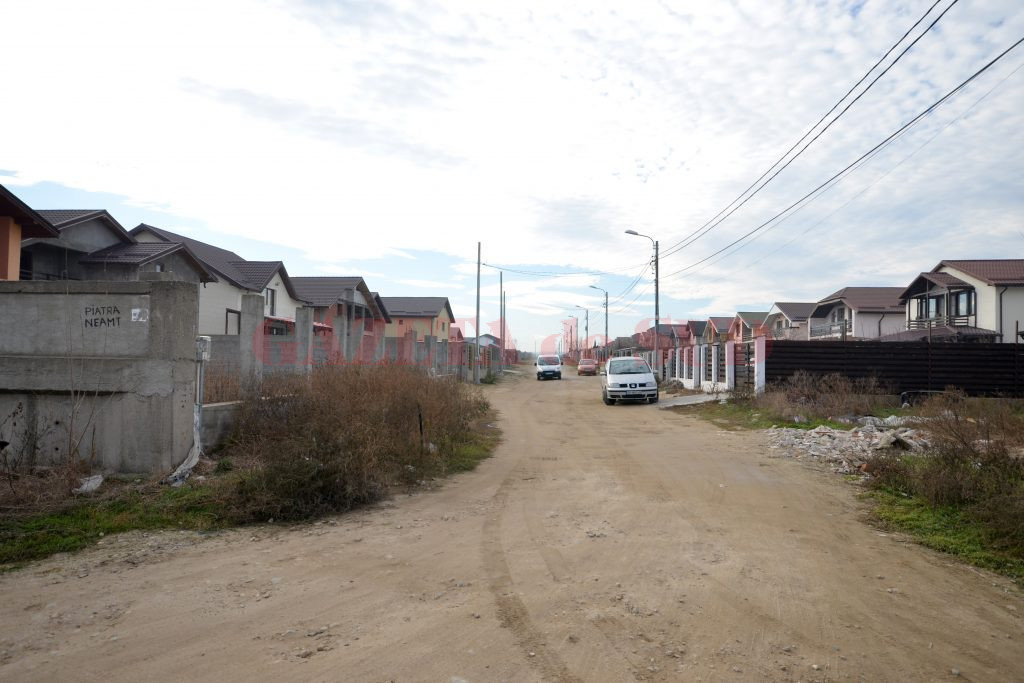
[227, 365, 486, 521]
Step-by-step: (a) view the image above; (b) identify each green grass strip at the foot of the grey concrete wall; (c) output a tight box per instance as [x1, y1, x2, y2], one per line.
[0, 485, 226, 569]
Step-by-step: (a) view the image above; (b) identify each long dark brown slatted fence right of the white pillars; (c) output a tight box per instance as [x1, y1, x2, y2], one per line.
[765, 340, 1024, 396]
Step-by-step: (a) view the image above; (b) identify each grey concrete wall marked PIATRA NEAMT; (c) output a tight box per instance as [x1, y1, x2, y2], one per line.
[0, 273, 199, 472]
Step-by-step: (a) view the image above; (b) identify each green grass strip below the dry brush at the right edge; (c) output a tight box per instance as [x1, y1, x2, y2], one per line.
[864, 488, 1024, 583]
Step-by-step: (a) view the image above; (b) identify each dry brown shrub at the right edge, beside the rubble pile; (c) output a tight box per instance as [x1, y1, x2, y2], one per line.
[872, 391, 1024, 549]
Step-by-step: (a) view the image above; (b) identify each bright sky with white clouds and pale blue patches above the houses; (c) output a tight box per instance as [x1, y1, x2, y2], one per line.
[0, 0, 1024, 349]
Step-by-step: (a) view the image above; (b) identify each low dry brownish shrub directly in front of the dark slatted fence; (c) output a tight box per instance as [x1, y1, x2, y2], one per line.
[756, 371, 897, 420]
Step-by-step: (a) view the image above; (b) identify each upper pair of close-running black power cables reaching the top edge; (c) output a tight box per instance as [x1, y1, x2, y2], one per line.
[663, 0, 959, 258]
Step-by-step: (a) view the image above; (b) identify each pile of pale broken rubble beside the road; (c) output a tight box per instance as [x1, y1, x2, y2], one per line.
[766, 416, 929, 474]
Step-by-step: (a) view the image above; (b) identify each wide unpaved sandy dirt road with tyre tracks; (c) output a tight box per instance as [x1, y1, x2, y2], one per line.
[0, 376, 1024, 683]
